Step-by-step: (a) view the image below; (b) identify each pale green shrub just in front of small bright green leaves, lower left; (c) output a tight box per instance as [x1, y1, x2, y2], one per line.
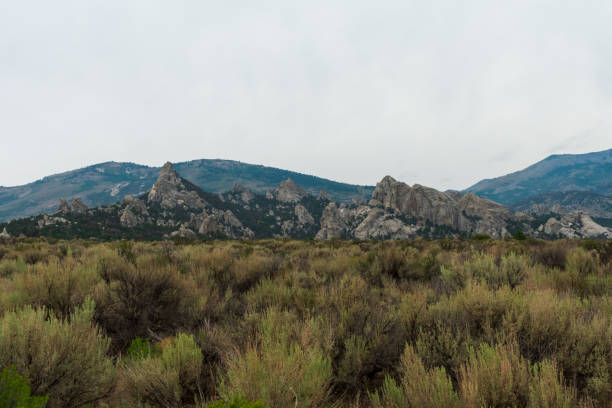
[125, 333, 202, 408]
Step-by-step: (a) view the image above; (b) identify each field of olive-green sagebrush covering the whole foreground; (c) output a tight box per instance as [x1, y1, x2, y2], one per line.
[0, 237, 612, 408]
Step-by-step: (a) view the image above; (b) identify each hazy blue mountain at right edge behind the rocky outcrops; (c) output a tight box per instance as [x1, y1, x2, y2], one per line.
[464, 149, 612, 218]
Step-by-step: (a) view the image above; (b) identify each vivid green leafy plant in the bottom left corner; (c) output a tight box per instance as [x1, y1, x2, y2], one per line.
[0, 366, 48, 408]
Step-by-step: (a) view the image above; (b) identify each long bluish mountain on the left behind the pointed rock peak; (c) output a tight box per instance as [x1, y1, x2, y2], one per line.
[0, 159, 374, 221]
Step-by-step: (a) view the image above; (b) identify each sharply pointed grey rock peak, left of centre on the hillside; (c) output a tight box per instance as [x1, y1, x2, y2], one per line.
[147, 162, 206, 209]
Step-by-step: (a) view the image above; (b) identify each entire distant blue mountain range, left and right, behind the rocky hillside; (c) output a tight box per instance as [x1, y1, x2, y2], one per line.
[0, 149, 612, 225]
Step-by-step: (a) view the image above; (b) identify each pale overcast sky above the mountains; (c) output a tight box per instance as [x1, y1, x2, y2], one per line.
[0, 0, 612, 190]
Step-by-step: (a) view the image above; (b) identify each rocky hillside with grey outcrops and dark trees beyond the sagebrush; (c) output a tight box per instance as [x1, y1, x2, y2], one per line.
[0, 163, 612, 240]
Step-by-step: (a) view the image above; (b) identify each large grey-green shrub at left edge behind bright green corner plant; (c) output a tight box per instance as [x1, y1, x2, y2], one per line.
[0, 301, 115, 408]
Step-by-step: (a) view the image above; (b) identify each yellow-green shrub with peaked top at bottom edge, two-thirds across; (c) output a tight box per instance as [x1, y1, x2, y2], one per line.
[370, 346, 460, 408]
